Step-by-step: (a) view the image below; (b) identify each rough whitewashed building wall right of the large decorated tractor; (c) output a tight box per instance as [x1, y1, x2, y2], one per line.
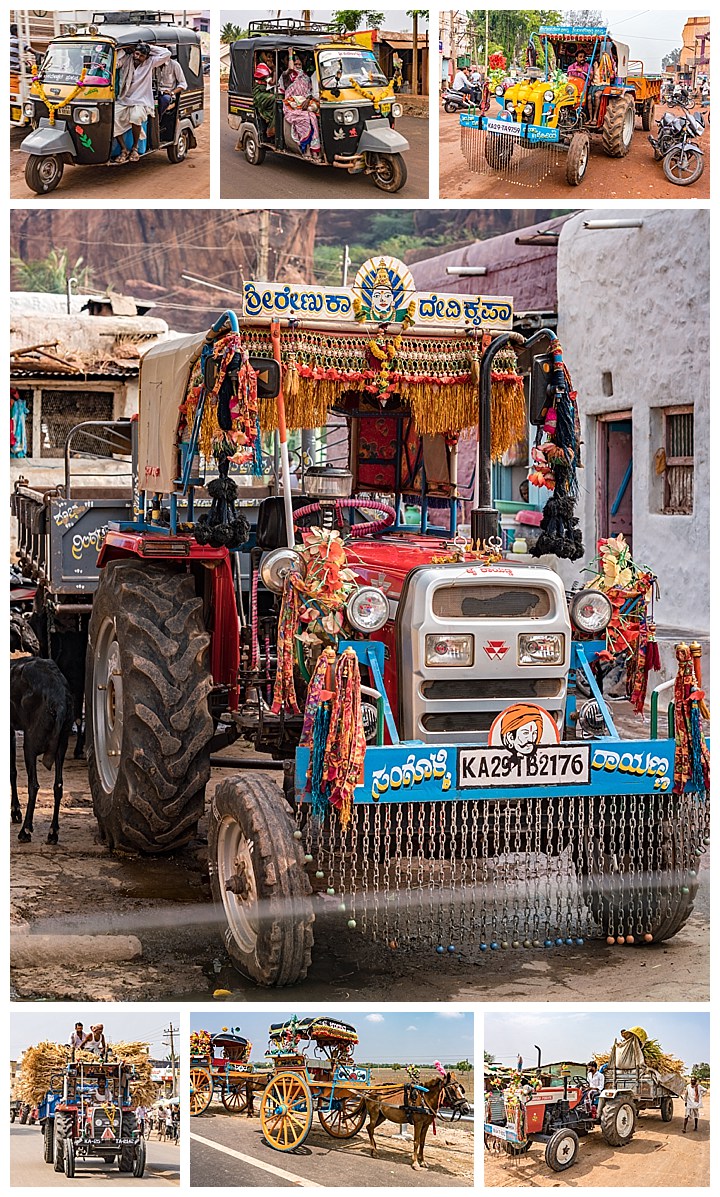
[557, 207, 709, 636]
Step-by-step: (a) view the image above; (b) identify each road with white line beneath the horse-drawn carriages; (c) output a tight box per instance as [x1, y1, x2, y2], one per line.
[190, 1112, 472, 1189]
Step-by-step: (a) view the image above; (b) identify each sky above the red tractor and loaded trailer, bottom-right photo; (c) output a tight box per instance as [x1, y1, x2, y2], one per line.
[484, 1007, 710, 1069]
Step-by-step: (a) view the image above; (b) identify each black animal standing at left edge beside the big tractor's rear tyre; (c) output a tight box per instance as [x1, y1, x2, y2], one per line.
[10, 657, 73, 844]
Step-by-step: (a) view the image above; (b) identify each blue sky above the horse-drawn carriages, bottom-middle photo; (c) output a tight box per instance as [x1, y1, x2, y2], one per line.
[190, 1008, 475, 1064]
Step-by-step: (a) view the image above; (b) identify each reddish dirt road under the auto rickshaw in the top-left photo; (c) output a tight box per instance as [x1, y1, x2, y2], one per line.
[10, 86, 210, 203]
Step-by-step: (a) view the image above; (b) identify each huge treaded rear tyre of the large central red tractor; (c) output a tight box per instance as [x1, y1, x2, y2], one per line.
[85, 560, 213, 852]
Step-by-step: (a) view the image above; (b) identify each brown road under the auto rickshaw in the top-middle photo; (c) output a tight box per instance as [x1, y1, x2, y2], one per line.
[215, 113, 428, 205]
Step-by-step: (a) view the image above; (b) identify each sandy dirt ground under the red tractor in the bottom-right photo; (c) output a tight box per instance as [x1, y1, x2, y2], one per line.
[483, 1098, 710, 1189]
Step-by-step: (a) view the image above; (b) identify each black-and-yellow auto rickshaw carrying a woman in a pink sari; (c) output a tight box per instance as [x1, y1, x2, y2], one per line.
[227, 18, 409, 192]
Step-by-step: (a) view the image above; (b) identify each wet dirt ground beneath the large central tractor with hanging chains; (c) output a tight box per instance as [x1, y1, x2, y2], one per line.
[10, 746, 709, 1002]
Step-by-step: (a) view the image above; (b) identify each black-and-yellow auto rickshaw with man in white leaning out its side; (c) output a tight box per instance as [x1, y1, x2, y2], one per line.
[20, 12, 205, 195]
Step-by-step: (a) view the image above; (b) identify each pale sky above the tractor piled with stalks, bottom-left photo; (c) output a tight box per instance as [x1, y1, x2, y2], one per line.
[10, 1004, 174, 1059]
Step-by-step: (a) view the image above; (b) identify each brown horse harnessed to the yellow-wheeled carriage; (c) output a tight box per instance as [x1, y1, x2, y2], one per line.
[365, 1073, 470, 1169]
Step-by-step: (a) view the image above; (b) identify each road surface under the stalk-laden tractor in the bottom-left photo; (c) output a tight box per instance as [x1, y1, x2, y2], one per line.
[10, 1123, 181, 1189]
